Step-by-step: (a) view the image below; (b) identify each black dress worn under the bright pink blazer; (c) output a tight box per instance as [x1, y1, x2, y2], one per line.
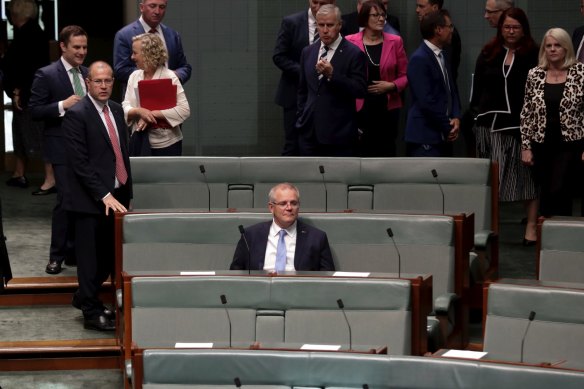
[357, 43, 399, 157]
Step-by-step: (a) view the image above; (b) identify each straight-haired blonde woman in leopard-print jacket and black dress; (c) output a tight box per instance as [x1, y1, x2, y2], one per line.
[521, 28, 584, 217]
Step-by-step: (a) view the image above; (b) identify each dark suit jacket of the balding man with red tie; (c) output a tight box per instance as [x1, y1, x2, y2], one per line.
[63, 96, 132, 214]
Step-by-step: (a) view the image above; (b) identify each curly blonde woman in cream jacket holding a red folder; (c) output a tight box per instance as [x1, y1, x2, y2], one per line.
[122, 33, 190, 156]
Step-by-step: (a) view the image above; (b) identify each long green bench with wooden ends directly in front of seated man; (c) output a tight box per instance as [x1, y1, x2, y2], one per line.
[123, 275, 431, 358]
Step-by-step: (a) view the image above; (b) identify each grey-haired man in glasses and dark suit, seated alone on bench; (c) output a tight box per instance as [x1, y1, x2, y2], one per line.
[230, 183, 335, 273]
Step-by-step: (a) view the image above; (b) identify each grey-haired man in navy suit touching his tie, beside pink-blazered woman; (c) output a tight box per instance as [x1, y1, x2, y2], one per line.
[296, 4, 367, 157]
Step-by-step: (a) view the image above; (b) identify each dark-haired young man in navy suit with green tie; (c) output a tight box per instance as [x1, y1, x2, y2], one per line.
[29, 25, 87, 274]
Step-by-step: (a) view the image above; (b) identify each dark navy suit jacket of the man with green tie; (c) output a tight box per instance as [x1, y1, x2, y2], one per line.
[29, 58, 87, 164]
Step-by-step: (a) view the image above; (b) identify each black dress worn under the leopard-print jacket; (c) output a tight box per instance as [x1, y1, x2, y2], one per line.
[532, 83, 584, 217]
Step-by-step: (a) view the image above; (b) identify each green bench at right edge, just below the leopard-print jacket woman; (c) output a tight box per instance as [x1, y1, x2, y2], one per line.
[537, 217, 584, 283]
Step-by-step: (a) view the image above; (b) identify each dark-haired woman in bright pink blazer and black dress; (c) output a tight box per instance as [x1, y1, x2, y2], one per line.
[345, 0, 408, 157]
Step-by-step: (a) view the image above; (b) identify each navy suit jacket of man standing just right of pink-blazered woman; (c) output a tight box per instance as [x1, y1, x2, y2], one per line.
[405, 42, 460, 144]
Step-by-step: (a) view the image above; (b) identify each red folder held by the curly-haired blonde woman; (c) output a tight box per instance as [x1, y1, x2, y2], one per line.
[138, 78, 176, 128]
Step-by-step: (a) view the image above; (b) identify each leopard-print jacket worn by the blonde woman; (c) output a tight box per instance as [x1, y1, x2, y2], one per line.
[521, 62, 584, 150]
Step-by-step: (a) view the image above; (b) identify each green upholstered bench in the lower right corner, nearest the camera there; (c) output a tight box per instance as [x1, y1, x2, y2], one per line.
[484, 279, 584, 369]
